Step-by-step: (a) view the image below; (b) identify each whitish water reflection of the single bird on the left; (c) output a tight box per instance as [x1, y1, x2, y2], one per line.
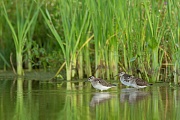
[90, 92, 114, 107]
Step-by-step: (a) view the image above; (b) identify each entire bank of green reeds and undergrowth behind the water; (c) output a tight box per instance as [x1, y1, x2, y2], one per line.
[0, 0, 180, 84]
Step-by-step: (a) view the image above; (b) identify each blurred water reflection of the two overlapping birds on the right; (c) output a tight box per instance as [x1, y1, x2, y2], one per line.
[120, 88, 150, 103]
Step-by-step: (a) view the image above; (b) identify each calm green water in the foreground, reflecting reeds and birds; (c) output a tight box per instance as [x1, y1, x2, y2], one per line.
[0, 79, 180, 120]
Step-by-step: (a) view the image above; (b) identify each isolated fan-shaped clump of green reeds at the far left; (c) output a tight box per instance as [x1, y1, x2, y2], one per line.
[2, 1, 38, 75]
